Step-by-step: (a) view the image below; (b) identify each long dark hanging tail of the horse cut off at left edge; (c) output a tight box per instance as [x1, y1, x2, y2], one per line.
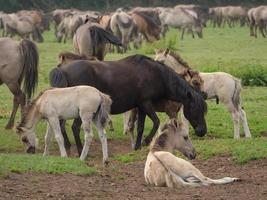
[19, 39, 39, 99]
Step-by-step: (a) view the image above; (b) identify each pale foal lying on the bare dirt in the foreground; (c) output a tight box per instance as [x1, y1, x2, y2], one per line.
[144, 120, 239, 188]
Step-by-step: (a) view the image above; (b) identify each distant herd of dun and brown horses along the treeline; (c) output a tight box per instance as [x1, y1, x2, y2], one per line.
[0, 4, 267, 48]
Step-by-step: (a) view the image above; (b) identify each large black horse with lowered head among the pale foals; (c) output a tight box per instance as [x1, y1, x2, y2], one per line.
[50, 55, 207, 152]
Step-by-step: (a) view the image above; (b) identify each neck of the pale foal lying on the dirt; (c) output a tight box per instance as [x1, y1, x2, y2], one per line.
[150, 133, 174, 153]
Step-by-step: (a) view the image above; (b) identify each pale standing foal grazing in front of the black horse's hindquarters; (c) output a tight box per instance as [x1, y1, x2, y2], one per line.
[17, 86, 111, 164]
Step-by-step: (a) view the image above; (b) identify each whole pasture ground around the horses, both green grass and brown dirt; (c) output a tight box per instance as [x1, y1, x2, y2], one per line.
[0, 27, 267, 199]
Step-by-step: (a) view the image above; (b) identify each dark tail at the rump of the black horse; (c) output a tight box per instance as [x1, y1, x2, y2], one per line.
[49, 67, 68, 88]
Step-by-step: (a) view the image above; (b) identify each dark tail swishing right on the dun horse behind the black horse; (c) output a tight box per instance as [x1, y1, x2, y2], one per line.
[89, 26, 122, 49]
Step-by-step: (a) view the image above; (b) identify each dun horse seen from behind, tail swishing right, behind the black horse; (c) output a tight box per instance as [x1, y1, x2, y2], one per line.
[73, 21, 122, 60]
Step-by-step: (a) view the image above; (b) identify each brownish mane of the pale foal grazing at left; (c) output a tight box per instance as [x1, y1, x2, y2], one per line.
[17, 88, 54, 128]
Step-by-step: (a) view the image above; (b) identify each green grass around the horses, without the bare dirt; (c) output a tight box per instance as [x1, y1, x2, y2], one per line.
[0, 25, 267, 175]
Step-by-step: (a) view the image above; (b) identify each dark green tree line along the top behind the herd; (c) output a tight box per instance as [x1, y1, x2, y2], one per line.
[0, 0, 267, 12]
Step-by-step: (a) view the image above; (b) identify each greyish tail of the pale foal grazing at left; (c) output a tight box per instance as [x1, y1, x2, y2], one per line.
[94, 93, 112, 126]
